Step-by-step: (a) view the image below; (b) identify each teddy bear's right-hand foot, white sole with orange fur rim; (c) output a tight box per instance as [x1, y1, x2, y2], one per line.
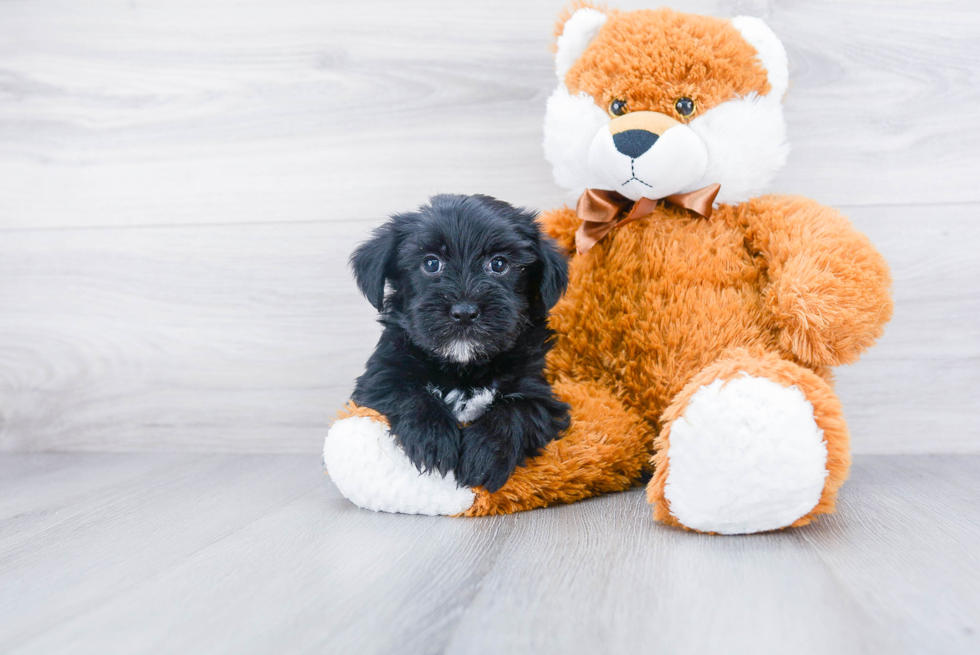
[647, 350, 850, 534]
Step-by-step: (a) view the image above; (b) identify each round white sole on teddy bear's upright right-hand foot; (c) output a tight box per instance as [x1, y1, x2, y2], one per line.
[664, 374, 827, 534]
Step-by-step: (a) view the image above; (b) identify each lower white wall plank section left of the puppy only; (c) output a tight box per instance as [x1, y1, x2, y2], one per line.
[0, 219, 377, 452]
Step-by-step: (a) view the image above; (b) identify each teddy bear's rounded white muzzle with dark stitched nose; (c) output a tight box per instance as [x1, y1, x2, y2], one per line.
[589, 111, 708, 200]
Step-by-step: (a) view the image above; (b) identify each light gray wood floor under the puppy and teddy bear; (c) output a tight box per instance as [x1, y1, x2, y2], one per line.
[0, 453, 980, 655]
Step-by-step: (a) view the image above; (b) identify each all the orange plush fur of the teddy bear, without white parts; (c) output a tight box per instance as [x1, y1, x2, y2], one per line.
[466, 9, 892, 525]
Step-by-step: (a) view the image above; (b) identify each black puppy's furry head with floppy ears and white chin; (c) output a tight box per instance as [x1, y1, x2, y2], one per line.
[352, 195, 567, 364]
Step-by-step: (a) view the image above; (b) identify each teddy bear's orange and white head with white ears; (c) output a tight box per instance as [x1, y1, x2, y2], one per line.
[544, 7, 789, 203]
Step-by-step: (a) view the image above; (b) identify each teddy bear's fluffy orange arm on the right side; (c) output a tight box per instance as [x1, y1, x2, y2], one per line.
[739, 196, 892, 366]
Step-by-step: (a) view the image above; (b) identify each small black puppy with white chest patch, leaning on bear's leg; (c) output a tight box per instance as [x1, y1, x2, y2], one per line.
[351, 195, 568, 491]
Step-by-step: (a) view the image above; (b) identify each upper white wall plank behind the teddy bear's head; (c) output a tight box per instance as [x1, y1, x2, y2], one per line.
[0, 0, 980, 228]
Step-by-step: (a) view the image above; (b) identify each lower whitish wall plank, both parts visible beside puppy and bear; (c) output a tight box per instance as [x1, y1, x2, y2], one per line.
[0, 205, 980, 453]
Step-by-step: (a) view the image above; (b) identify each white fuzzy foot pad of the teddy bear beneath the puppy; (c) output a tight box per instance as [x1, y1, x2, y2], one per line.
[323, 416, 475, 515]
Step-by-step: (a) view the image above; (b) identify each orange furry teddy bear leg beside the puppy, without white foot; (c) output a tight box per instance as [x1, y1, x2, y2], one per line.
[465, 380, 653, 516]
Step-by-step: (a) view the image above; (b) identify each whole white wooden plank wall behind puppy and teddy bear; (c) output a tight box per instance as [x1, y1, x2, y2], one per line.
[0, 0, 980, 453]
